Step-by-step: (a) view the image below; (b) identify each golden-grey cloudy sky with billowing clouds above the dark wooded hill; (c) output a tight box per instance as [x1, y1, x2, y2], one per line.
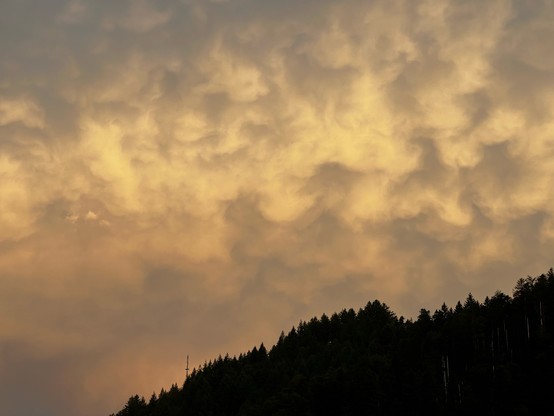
[0, 0, 554, 416]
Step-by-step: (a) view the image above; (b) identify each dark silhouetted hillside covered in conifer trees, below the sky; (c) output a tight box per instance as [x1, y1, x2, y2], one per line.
[112, 269, 554, 416]
